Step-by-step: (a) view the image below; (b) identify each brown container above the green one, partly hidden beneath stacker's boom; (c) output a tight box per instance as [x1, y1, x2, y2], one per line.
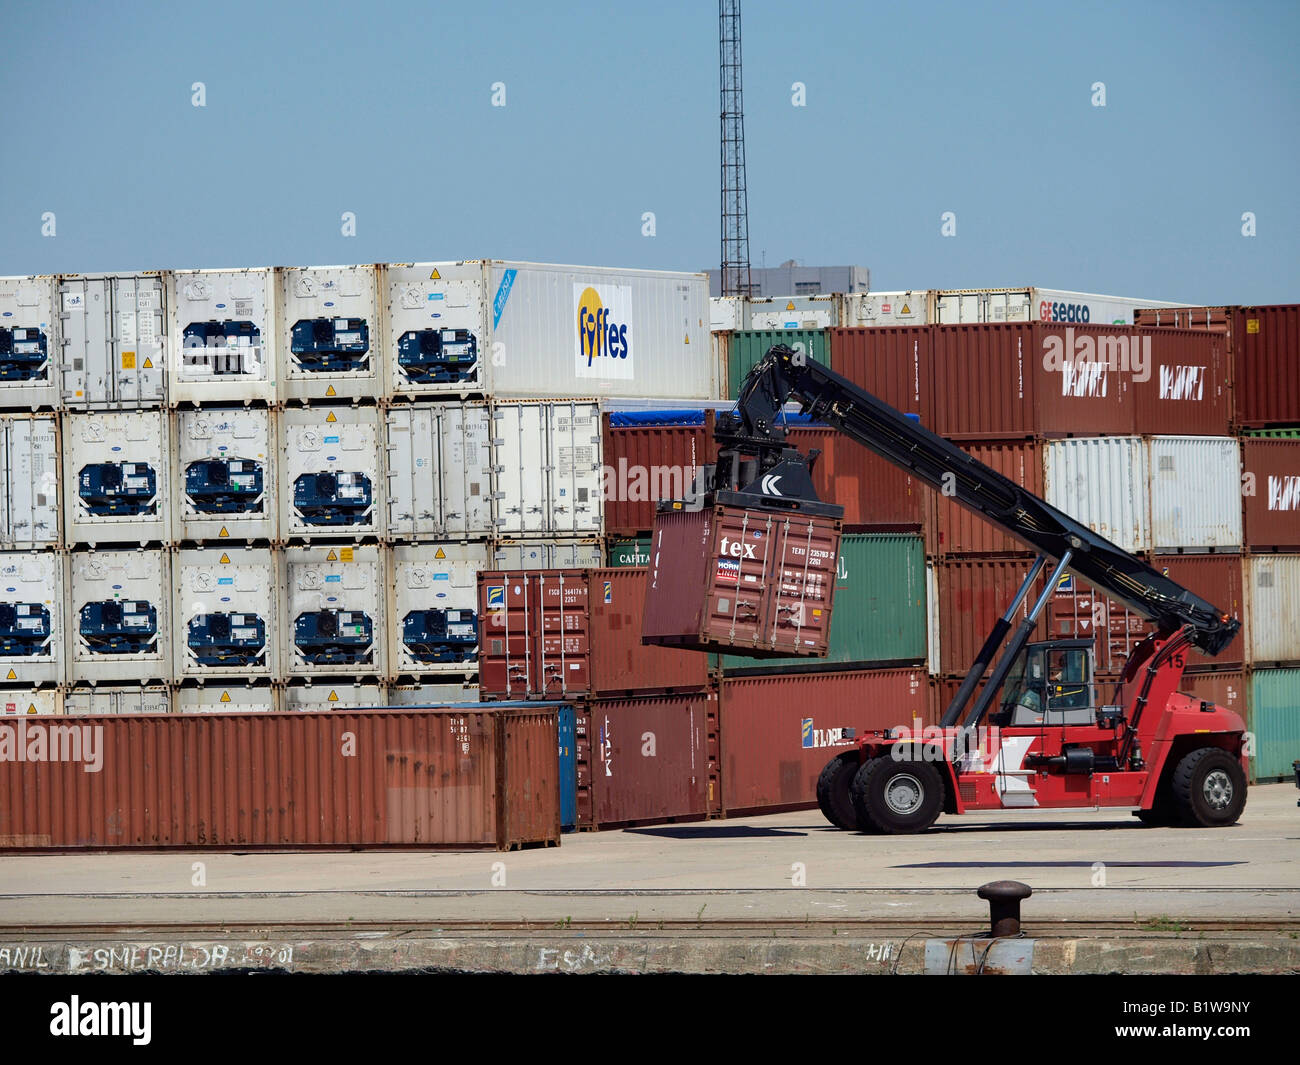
[787, 425, 928, 532]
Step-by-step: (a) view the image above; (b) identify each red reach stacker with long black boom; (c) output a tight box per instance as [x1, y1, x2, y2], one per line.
[701, 346, 1247, 832]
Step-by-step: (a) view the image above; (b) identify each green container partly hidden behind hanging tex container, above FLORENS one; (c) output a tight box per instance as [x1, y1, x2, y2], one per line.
[723, 533, 926, 674]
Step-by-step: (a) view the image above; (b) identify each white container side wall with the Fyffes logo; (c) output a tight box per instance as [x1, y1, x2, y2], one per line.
[486, 260, 719, 399]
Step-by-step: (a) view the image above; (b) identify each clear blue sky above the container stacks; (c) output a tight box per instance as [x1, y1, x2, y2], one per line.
[0, 0, 1300, 303]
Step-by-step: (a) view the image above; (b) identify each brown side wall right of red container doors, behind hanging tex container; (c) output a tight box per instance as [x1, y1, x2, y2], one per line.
[590, 567, 709, 697]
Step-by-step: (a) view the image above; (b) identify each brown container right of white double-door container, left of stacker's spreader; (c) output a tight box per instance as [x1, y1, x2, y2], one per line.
[603, 411, 718, 537]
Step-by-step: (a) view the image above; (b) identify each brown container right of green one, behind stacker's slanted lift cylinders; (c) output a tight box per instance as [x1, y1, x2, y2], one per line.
[935, 558, 1047, 676]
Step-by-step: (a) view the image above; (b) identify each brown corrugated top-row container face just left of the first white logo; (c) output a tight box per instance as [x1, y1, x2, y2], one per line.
[927, 322, 1041, 440]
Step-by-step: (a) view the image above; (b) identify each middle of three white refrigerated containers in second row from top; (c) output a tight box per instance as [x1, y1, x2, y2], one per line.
[172, 407, 281, 541]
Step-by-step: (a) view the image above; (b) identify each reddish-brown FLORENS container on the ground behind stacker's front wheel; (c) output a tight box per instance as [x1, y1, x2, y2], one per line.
[720, 670, 933, 814]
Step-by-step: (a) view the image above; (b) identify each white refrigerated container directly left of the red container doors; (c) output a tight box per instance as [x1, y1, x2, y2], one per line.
[389, 544, 489, 681]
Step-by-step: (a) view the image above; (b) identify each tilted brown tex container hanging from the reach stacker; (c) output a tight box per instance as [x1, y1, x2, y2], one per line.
[642, 506, 840, 658]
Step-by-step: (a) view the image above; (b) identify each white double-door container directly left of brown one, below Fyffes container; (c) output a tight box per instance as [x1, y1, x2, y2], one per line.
[491, 401, 605, 537]
